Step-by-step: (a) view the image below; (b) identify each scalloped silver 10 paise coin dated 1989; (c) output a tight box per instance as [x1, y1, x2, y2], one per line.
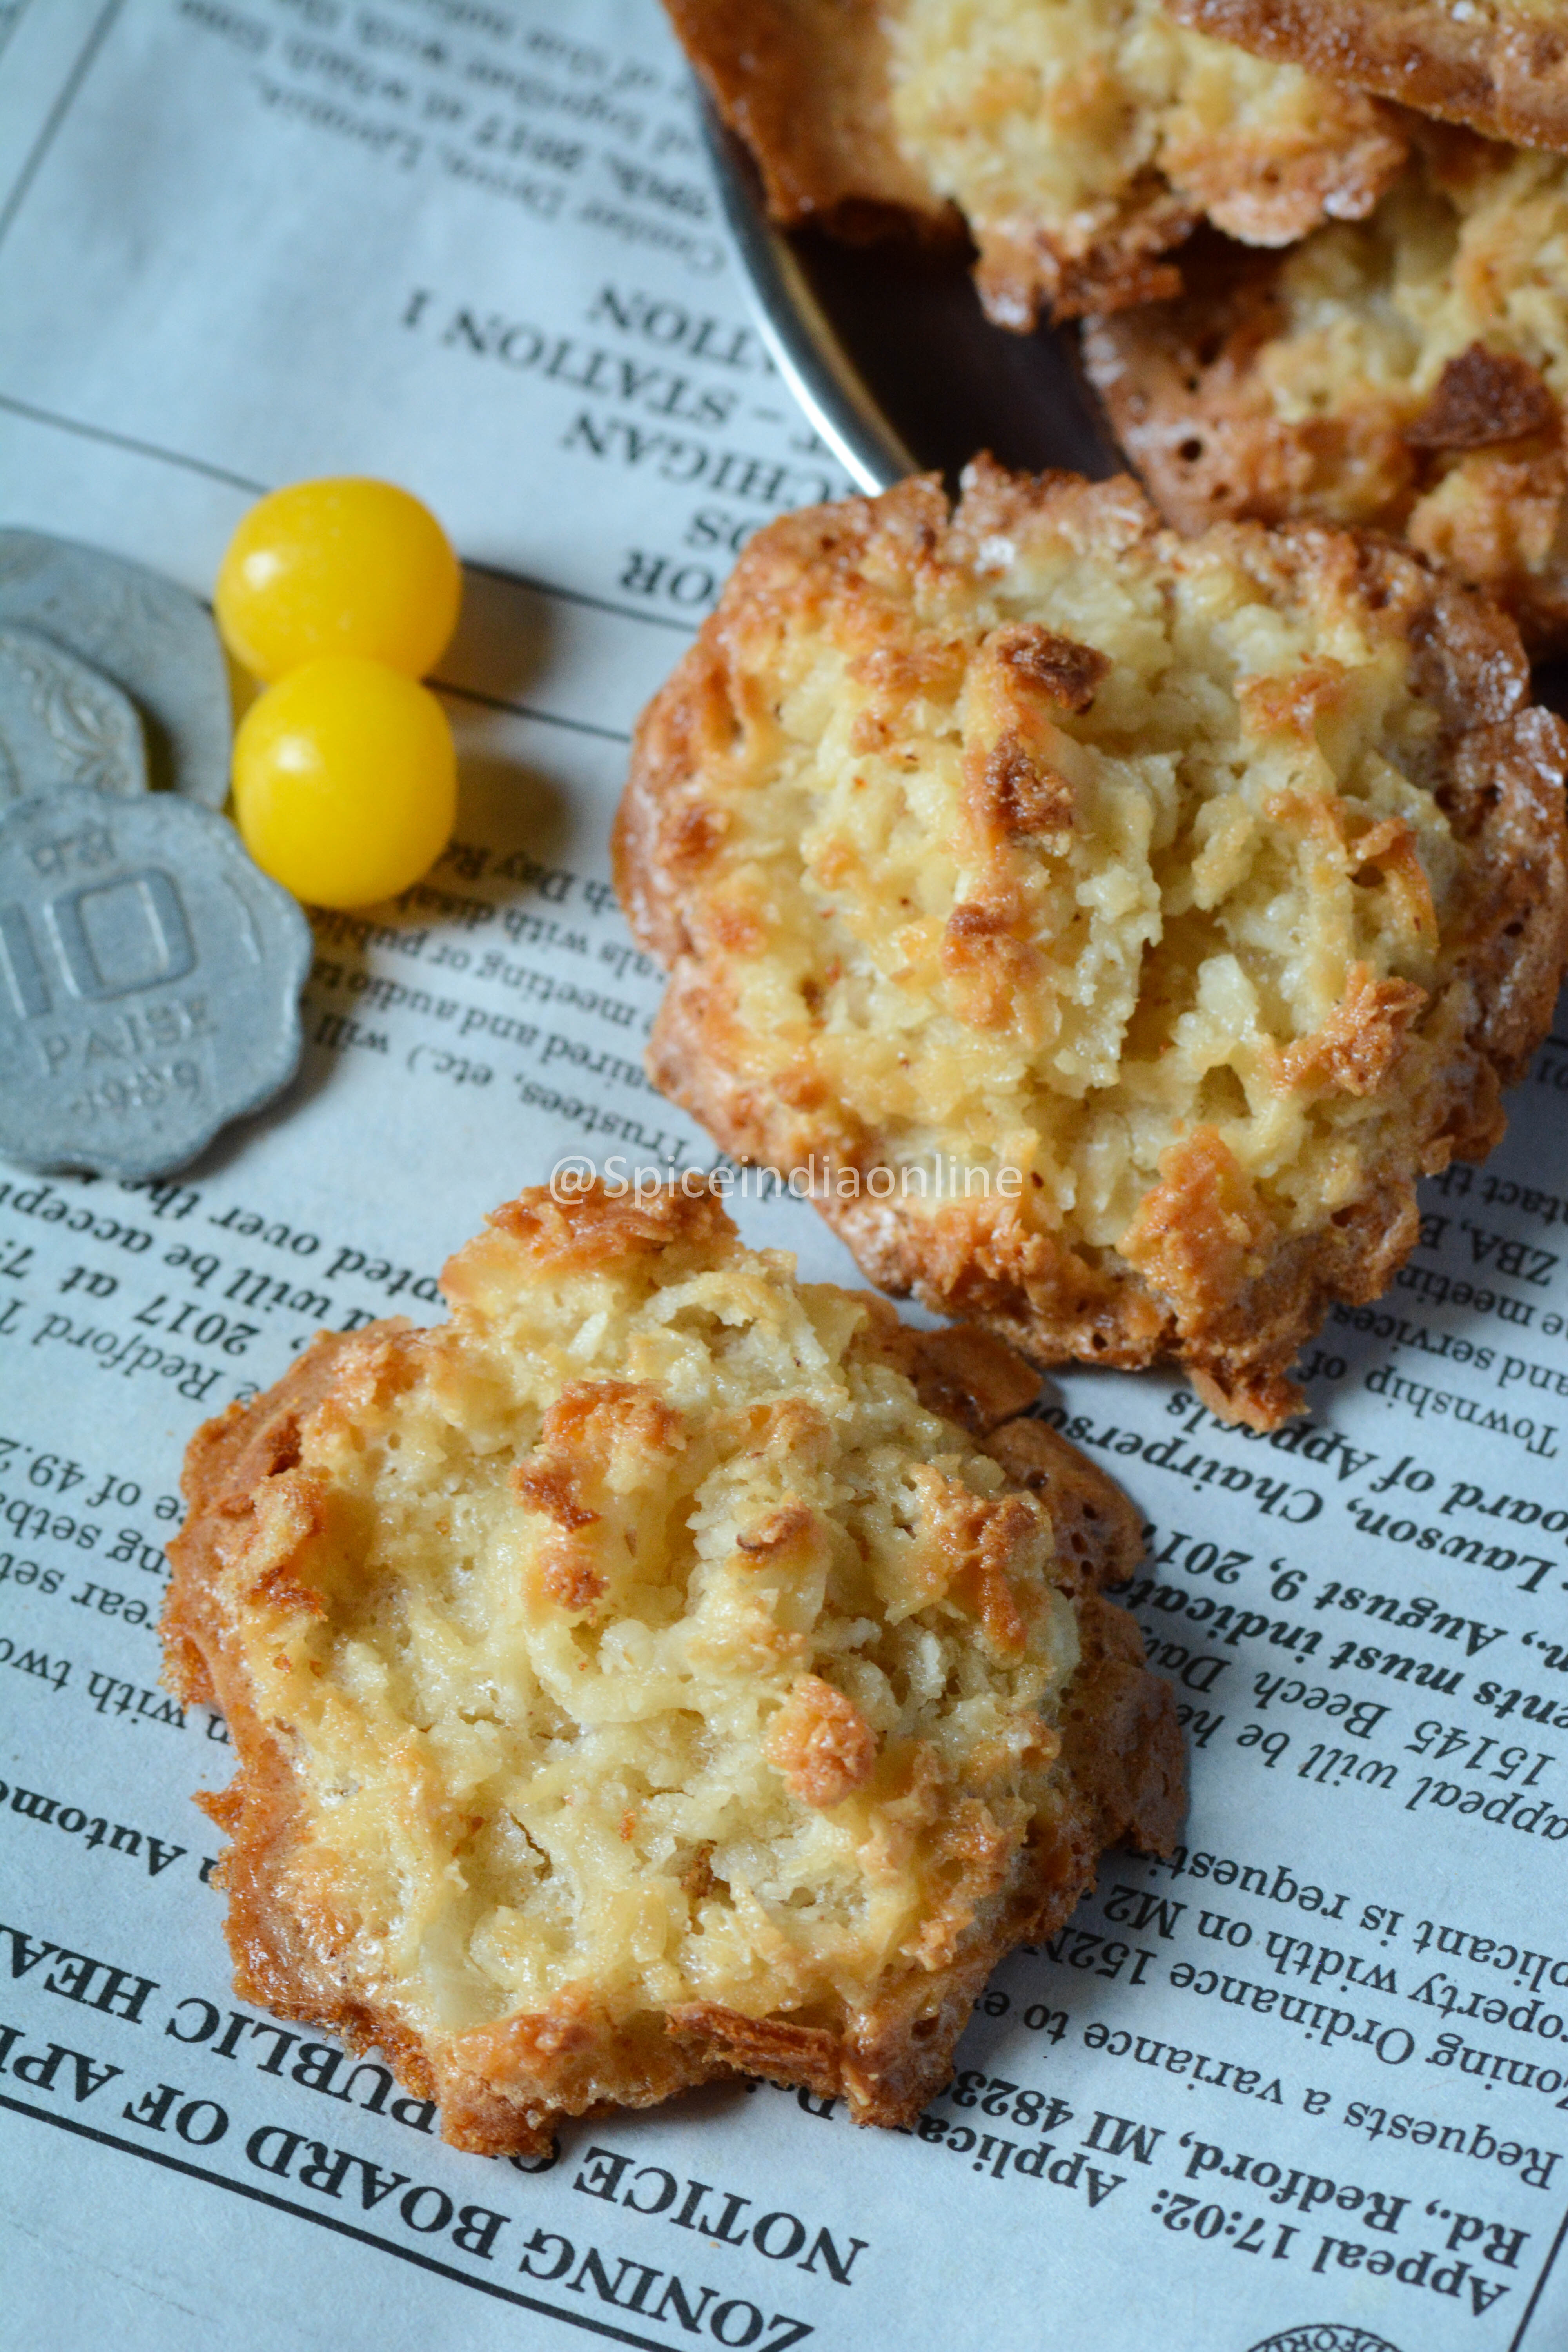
[0, 786, 310, 1176]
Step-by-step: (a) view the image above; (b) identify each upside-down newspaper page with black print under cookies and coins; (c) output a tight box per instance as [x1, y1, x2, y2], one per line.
[0, 0, 1568, 2352]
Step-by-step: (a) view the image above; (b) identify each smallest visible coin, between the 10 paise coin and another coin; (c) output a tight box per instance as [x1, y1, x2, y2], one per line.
[0, 628, 148, 800]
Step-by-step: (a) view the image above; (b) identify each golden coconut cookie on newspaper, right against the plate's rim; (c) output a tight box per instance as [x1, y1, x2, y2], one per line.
[616, 461, 1568, 1428]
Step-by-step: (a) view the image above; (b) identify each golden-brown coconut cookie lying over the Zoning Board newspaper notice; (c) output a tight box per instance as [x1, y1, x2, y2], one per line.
[162, 1190, 1182, 2154]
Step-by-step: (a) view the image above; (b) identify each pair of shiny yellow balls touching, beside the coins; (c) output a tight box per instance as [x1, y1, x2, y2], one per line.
[214, 477, 463, 906]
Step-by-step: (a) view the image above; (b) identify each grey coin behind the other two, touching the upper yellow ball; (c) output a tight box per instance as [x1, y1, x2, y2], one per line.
[0, 532, 233, 809]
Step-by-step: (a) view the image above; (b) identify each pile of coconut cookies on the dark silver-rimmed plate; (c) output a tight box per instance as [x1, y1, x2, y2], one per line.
[670, 0, 1568, 654]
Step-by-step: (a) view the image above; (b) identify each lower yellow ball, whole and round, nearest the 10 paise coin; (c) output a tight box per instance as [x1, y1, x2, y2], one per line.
[235, 654, 456, 906]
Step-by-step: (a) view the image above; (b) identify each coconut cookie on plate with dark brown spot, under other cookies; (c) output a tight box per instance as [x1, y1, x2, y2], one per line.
[1084, 125, 1568, 652]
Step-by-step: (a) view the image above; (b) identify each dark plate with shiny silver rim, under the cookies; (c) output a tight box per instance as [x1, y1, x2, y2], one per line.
[703, 103, 1117, 489]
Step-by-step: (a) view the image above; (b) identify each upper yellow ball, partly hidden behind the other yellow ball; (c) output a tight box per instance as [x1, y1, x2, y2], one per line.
[212, 475, 463, 677]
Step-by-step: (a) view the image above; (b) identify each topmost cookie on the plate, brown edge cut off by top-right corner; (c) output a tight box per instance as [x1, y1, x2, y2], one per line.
[1166, 0, 1568, 148]
